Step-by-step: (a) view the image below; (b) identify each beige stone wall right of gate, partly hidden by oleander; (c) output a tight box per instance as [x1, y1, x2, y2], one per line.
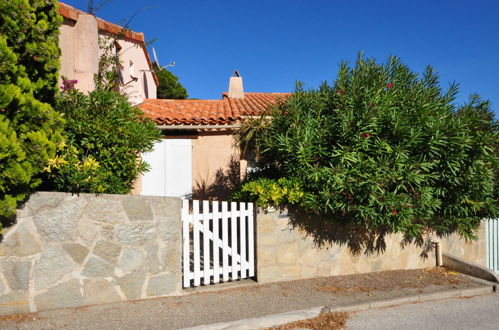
[256, 212, 486, 283]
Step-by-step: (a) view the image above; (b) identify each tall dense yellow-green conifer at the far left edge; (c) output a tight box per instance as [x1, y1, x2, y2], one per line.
[0, 0, 63, 227]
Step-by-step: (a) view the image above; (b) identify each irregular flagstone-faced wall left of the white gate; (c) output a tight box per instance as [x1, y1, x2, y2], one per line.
[0, 192, 182, 314]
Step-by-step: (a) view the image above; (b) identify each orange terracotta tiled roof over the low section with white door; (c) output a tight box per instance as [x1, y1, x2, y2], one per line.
[139, 93, 291, 125]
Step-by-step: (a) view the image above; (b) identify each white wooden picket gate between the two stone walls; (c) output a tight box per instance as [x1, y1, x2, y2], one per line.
[182, 200, 255, 288]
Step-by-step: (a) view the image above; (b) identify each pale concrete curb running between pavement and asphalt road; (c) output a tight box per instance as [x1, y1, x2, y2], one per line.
[183, 285, 494, 330]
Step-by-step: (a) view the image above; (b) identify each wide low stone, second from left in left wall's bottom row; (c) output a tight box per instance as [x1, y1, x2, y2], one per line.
[34, 280, 84, 311]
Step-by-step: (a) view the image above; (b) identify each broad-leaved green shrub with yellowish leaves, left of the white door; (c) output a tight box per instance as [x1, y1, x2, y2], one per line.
[46, 89, 160, 194]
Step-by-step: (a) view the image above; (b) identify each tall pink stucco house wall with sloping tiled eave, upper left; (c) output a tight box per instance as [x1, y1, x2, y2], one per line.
[59, 2, 158, 105]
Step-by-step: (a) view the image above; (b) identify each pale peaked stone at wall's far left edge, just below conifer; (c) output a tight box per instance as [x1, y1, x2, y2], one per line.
[0, 219, 41, 257]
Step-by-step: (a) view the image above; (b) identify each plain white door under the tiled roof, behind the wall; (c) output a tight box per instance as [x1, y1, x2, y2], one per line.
[141, 139, 192, 198]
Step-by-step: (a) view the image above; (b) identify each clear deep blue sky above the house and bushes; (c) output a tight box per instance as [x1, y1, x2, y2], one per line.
[61, 0, 499, 114]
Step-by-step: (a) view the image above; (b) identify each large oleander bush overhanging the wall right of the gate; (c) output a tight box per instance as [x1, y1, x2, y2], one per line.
[238, 55, 499, 249]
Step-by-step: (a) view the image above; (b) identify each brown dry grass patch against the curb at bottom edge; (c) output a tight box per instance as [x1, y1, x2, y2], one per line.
[270, 312, 350, 330]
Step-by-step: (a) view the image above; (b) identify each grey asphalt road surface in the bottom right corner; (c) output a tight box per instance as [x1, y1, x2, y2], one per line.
[347, 293, 499, 330]
